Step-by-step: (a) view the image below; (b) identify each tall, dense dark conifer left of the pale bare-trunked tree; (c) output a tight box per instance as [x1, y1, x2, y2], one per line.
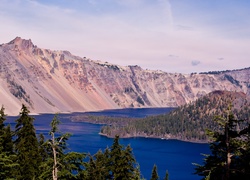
[14, 105, 41, 180]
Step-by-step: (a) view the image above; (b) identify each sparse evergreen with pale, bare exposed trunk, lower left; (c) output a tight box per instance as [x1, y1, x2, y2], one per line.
[39, 114, 86, 180]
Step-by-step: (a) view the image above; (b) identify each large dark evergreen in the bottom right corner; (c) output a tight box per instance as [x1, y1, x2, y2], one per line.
[195, 106, 250, 180]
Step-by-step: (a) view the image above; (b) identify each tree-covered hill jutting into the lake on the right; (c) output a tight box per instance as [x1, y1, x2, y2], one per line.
[95, 91, 250, 142]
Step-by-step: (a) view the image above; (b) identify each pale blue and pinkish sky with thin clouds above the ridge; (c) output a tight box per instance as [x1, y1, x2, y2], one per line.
[0, 0, 250, 73]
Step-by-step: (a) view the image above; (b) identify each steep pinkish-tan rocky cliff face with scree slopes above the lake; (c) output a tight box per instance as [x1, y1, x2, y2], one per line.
[0, 37, 250, 115]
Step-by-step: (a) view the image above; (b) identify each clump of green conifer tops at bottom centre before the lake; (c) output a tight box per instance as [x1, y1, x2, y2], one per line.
[86, 136, 140, 180]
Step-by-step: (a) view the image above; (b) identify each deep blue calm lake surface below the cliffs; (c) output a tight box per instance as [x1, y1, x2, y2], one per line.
[6, 108, 209, 180]
